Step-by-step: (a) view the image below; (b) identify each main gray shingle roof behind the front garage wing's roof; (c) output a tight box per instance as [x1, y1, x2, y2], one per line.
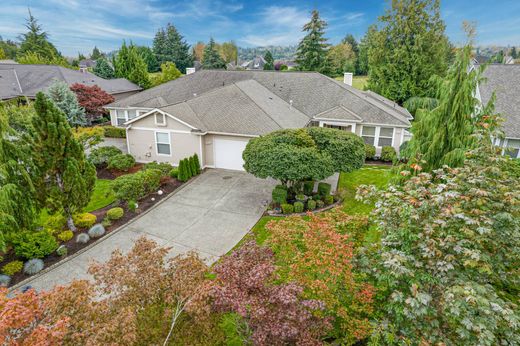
[107, 70, 411, 131]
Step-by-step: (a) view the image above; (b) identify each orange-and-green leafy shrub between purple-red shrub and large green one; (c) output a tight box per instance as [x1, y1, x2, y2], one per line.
[267, 210, 374, 344]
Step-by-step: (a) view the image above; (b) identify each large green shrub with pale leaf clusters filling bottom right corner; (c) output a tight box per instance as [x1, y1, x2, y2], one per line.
[358, 149, 520, 345]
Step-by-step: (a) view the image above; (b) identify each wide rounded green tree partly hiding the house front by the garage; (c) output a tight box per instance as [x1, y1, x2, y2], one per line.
[243, 127, 365, 187]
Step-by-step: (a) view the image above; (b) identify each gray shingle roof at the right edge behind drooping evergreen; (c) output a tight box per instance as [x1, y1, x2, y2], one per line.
[479, 64, 520, 138]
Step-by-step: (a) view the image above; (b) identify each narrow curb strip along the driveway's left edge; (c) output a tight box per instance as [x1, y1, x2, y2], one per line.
[8, 174, 202, 293]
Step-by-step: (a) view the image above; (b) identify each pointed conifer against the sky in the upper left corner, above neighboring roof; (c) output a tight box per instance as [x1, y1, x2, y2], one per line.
[17, 10, 61, 60]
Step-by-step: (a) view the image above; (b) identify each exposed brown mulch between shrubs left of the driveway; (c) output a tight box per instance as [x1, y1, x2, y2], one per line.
[0, 174, 182, 286]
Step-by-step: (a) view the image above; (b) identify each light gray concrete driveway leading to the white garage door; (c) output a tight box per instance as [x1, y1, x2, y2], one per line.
[18, 169, 275, 290]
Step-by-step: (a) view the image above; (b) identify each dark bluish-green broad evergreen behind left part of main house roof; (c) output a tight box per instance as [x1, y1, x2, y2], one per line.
[153, 23, 193, 73]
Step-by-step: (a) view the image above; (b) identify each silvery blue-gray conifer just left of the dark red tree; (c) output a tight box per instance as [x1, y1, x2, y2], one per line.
[45, 80, 87, 127]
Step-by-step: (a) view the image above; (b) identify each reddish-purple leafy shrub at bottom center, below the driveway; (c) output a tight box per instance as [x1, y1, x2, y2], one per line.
[212, 242, 328, 345]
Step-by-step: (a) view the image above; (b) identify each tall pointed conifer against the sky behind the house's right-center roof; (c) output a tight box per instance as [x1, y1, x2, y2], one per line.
[296, 10, 328, 71]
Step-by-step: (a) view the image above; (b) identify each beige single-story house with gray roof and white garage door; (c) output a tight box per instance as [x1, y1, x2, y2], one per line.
[106, 70, 412, 170]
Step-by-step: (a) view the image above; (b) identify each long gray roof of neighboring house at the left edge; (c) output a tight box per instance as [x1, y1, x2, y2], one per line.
[0, 64, 142, 100]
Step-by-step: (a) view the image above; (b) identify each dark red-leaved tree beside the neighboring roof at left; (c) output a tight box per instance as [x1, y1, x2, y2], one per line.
[70, 83, 114, 123]
